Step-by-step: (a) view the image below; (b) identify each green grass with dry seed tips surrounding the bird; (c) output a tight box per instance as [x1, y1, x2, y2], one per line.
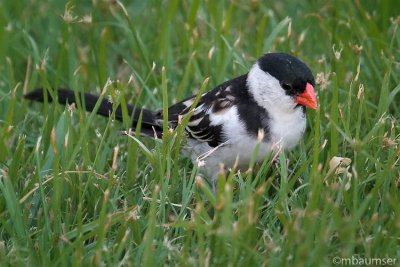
[0, 0, 400, 266]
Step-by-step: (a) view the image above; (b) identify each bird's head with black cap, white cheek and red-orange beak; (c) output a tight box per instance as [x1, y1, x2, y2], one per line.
[247, 53, 318, 112]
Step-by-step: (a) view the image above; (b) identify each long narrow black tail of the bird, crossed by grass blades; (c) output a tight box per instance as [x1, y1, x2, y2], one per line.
[24, 88, 162, 136]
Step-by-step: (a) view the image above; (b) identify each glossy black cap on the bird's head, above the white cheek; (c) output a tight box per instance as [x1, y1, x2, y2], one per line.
[258, 53, 315, 95]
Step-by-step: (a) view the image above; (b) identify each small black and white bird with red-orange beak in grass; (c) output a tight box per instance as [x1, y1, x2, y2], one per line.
[25, 53, 317, 183]
